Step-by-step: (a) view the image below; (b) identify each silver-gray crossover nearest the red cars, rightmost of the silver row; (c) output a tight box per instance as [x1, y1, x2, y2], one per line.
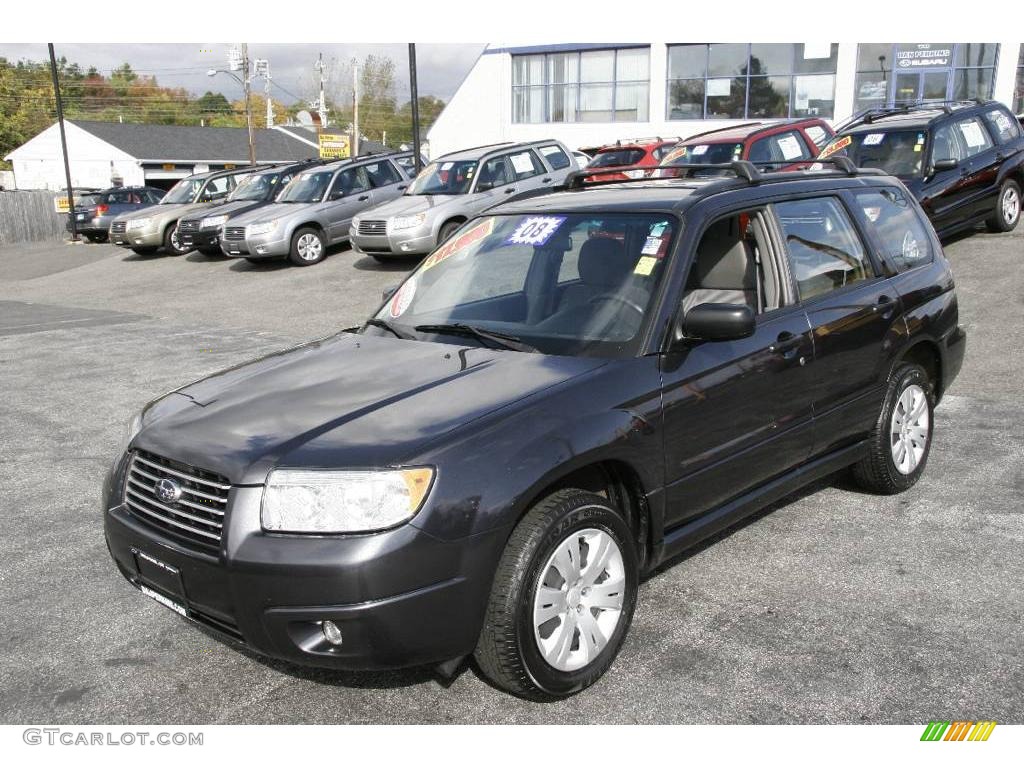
[349, 139, 579, 261]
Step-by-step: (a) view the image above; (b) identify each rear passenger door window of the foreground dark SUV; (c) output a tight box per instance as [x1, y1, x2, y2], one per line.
[774, 198, 874, 301]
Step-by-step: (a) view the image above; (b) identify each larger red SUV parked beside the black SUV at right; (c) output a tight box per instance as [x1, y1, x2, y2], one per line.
[660, 118, 836, 170]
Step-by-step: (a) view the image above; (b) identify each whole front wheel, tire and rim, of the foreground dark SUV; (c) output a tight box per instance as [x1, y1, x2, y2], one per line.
[475, 488, 639, 700]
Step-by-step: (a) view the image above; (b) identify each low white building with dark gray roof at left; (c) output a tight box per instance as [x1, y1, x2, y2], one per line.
[4, 120, 319, 189]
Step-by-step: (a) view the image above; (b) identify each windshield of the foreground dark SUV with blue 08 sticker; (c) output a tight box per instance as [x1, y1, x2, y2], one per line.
[365, 213, 678, 357]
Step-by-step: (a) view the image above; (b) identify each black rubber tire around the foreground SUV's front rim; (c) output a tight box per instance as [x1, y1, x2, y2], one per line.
[474, 488, 639, 700]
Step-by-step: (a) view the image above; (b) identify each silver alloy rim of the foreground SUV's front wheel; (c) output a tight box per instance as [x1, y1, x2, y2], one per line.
[534, 528, 626, 672]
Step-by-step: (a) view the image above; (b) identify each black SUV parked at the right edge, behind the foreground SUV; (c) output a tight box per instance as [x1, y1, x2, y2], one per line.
[819, 101, 1024, 238]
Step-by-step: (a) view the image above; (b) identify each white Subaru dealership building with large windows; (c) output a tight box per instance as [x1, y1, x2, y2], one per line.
[428, 42, 1024, 157]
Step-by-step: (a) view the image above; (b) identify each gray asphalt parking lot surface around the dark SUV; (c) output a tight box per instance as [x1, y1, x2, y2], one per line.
[0, 227, 1024, 724]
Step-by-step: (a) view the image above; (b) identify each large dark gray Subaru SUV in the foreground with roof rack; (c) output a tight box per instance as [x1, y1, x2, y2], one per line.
[102, 161, 966, 698]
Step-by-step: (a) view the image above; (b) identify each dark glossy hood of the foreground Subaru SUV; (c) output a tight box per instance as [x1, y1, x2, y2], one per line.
[134, 334, 604, 484]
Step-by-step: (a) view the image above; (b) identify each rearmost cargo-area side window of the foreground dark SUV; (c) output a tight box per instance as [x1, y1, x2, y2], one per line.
[854, 187, 933, 272]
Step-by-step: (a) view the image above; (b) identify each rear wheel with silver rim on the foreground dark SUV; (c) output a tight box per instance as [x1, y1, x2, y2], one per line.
[853, 364, 935, 494]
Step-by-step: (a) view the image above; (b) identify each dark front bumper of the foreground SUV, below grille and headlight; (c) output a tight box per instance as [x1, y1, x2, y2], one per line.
[103, 456, 507, 670]
